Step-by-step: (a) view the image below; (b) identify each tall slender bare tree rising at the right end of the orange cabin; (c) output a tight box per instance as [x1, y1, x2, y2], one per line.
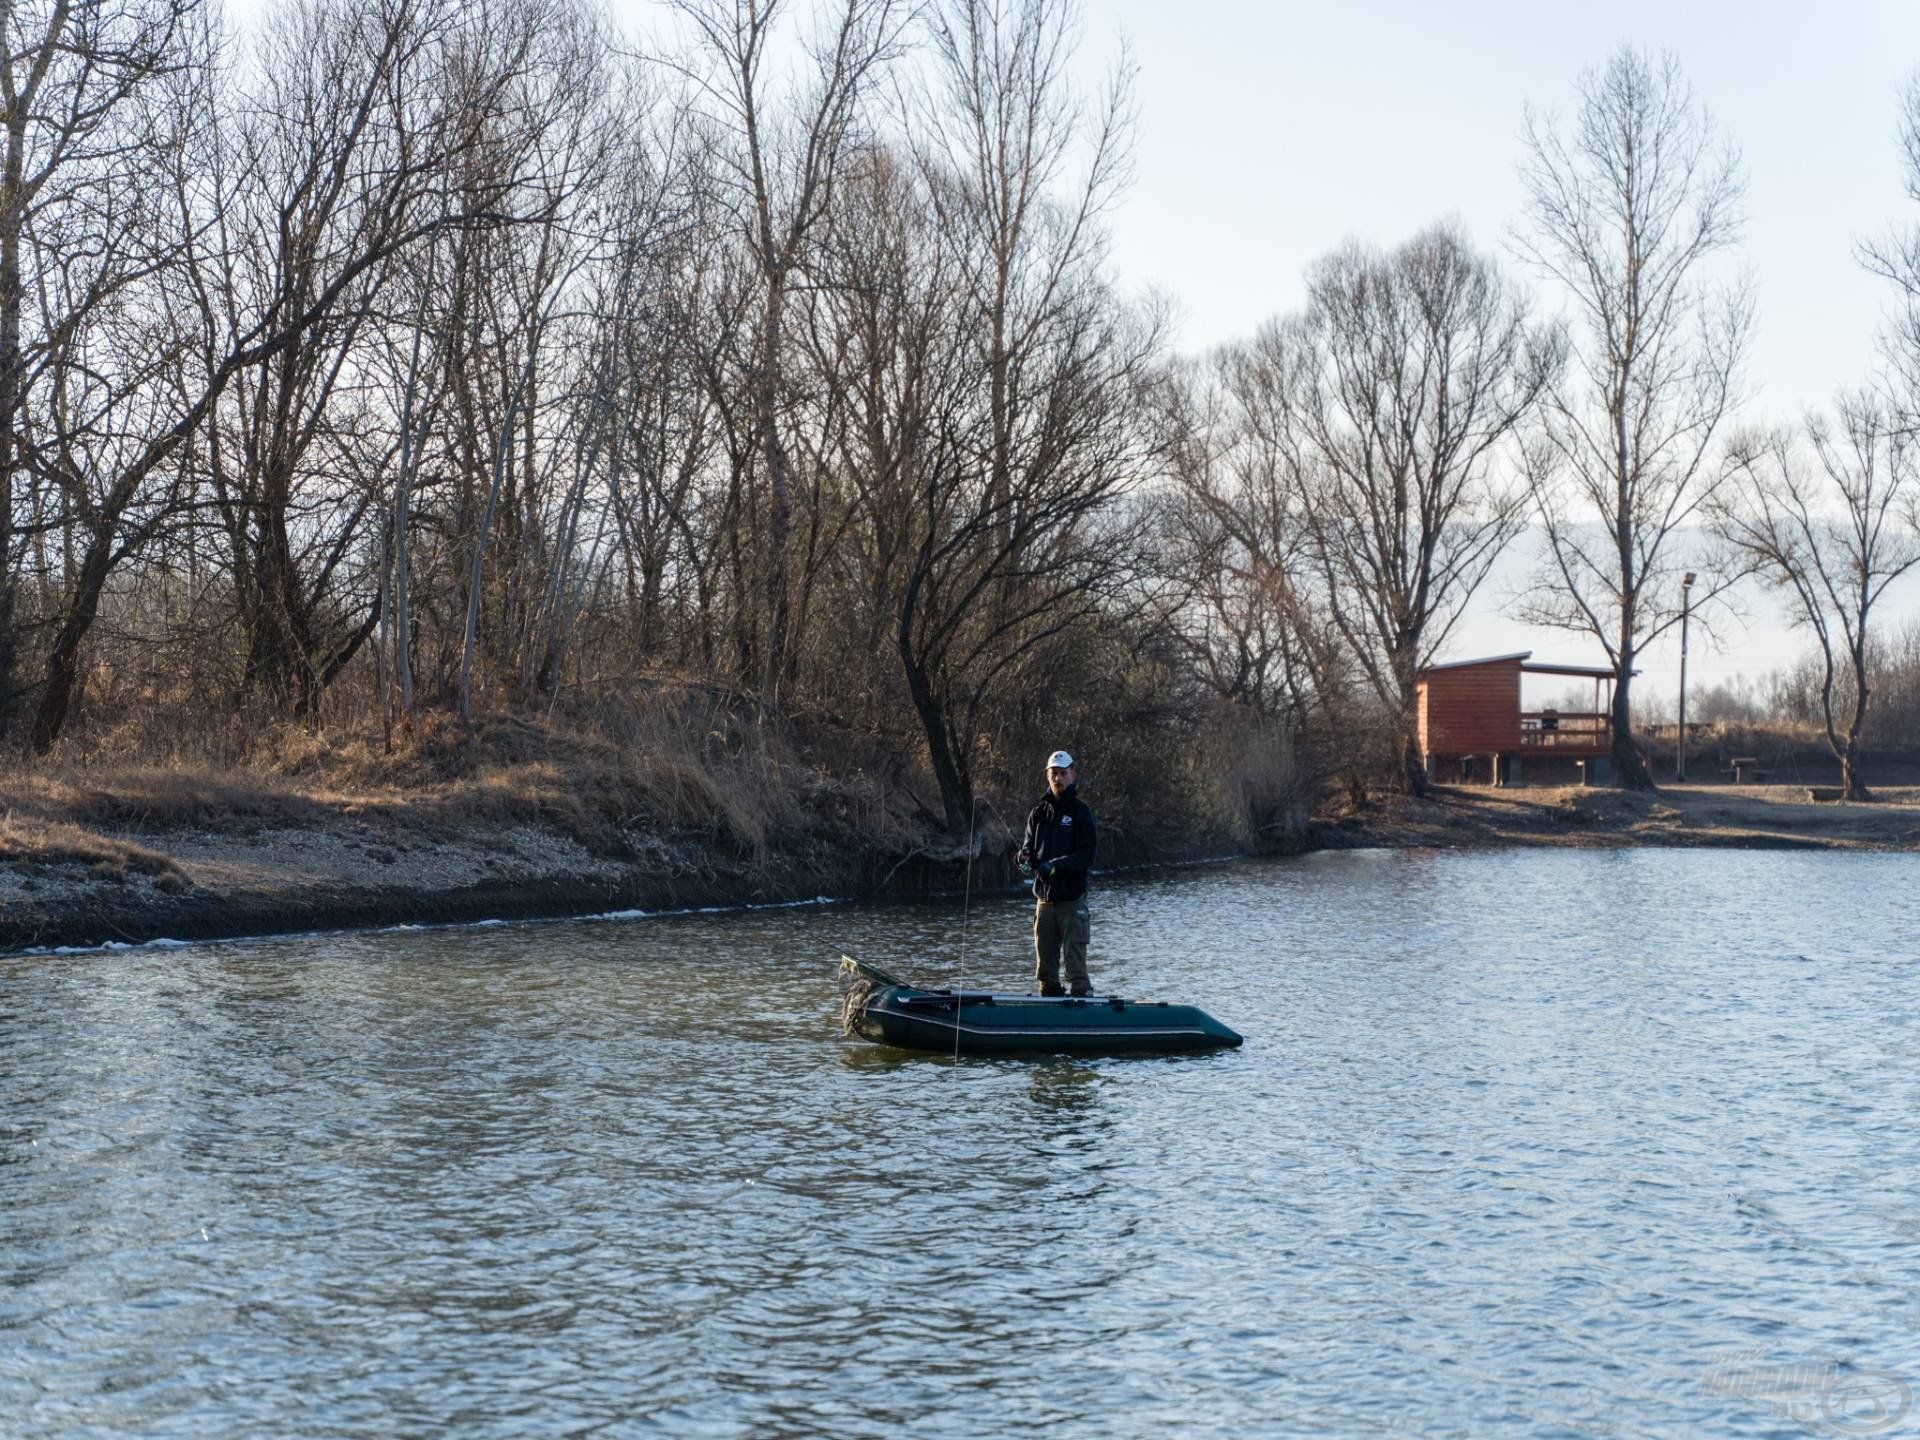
[1515, 48, 1753, 789]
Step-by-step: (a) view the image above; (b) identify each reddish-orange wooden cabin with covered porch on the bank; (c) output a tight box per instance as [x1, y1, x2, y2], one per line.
[1415, 651, 1619, 785]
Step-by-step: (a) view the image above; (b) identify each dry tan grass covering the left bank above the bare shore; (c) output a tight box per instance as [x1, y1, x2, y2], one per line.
[0, 682, 921, 876]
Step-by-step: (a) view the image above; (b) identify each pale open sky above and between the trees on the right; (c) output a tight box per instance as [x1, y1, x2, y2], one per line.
[1081, 0, 1920, 697]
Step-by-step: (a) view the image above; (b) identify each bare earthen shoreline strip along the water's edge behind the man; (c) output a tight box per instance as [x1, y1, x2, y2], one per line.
[0, 783, 1920, 954]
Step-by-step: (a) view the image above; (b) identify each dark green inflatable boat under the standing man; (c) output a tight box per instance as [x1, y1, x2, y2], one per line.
[852, 985, 1240, 1054]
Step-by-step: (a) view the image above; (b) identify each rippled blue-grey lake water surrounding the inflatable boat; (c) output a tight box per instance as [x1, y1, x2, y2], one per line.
[0, 851, 1920, 1438]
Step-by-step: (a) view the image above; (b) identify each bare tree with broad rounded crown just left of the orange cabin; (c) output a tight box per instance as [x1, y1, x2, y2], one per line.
[1282, 225, 1561, 793]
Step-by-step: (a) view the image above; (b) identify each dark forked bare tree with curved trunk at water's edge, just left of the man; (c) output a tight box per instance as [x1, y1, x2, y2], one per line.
[810, 144, 1160, 837]
